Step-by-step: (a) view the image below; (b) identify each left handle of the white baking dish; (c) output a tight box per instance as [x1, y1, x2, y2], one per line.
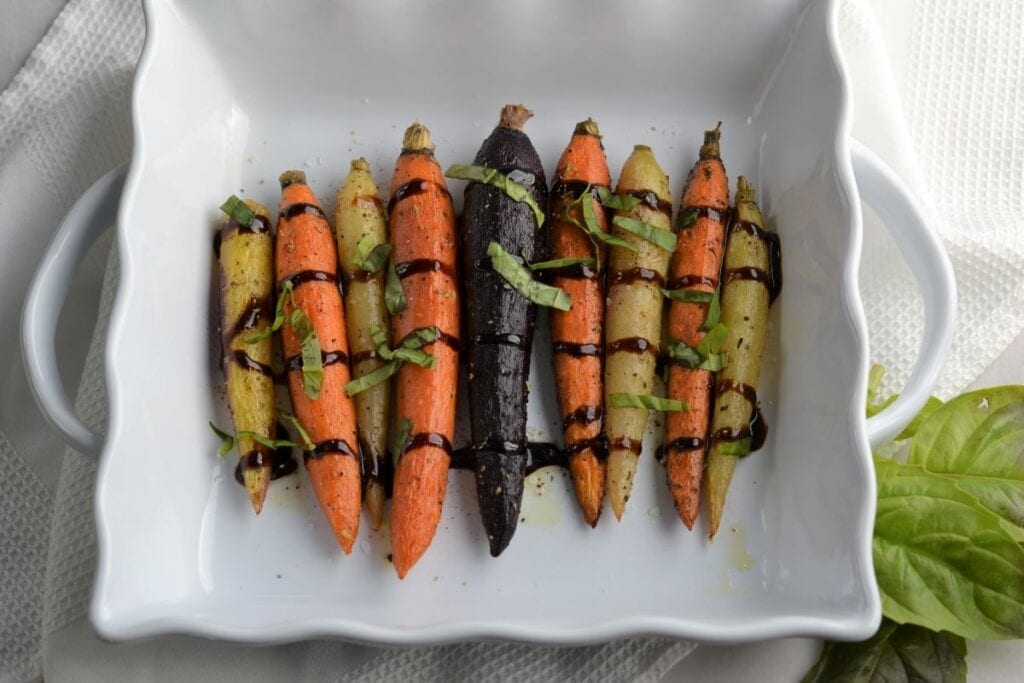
[22, 165, 127, 456]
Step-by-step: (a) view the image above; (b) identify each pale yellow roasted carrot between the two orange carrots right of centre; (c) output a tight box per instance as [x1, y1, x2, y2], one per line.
[604, 144, 675, 518]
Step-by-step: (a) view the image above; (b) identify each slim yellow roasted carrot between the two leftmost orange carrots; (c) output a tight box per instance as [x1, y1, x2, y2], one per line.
[335, 159, 391, 529]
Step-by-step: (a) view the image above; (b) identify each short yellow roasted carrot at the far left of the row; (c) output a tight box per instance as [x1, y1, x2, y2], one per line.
[220, 198, 276, 514]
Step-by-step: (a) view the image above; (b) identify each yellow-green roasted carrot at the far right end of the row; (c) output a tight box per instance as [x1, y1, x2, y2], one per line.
[706, 176, 781, 538]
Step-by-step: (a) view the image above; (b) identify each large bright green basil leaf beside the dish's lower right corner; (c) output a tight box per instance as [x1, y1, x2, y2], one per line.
[872, 458, 1024, 639]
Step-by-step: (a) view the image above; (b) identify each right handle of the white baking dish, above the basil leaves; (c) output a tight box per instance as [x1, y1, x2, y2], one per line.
[850, 140, 956, 446]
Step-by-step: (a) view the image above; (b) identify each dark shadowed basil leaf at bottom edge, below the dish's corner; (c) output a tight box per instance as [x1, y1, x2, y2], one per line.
[801, 620, 967, 683]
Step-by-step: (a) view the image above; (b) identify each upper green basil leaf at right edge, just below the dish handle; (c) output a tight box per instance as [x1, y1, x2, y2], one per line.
[907, 386, 1024, 541]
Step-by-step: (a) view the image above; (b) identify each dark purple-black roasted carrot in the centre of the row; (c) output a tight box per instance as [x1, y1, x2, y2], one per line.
[462, 105, 548, 557]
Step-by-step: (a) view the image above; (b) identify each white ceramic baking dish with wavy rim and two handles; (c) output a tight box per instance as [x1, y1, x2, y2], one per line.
[24, 0, 954, 644]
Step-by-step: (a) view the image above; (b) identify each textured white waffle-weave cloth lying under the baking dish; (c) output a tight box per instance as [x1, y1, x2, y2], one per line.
[0, 0, 1024, 681]
